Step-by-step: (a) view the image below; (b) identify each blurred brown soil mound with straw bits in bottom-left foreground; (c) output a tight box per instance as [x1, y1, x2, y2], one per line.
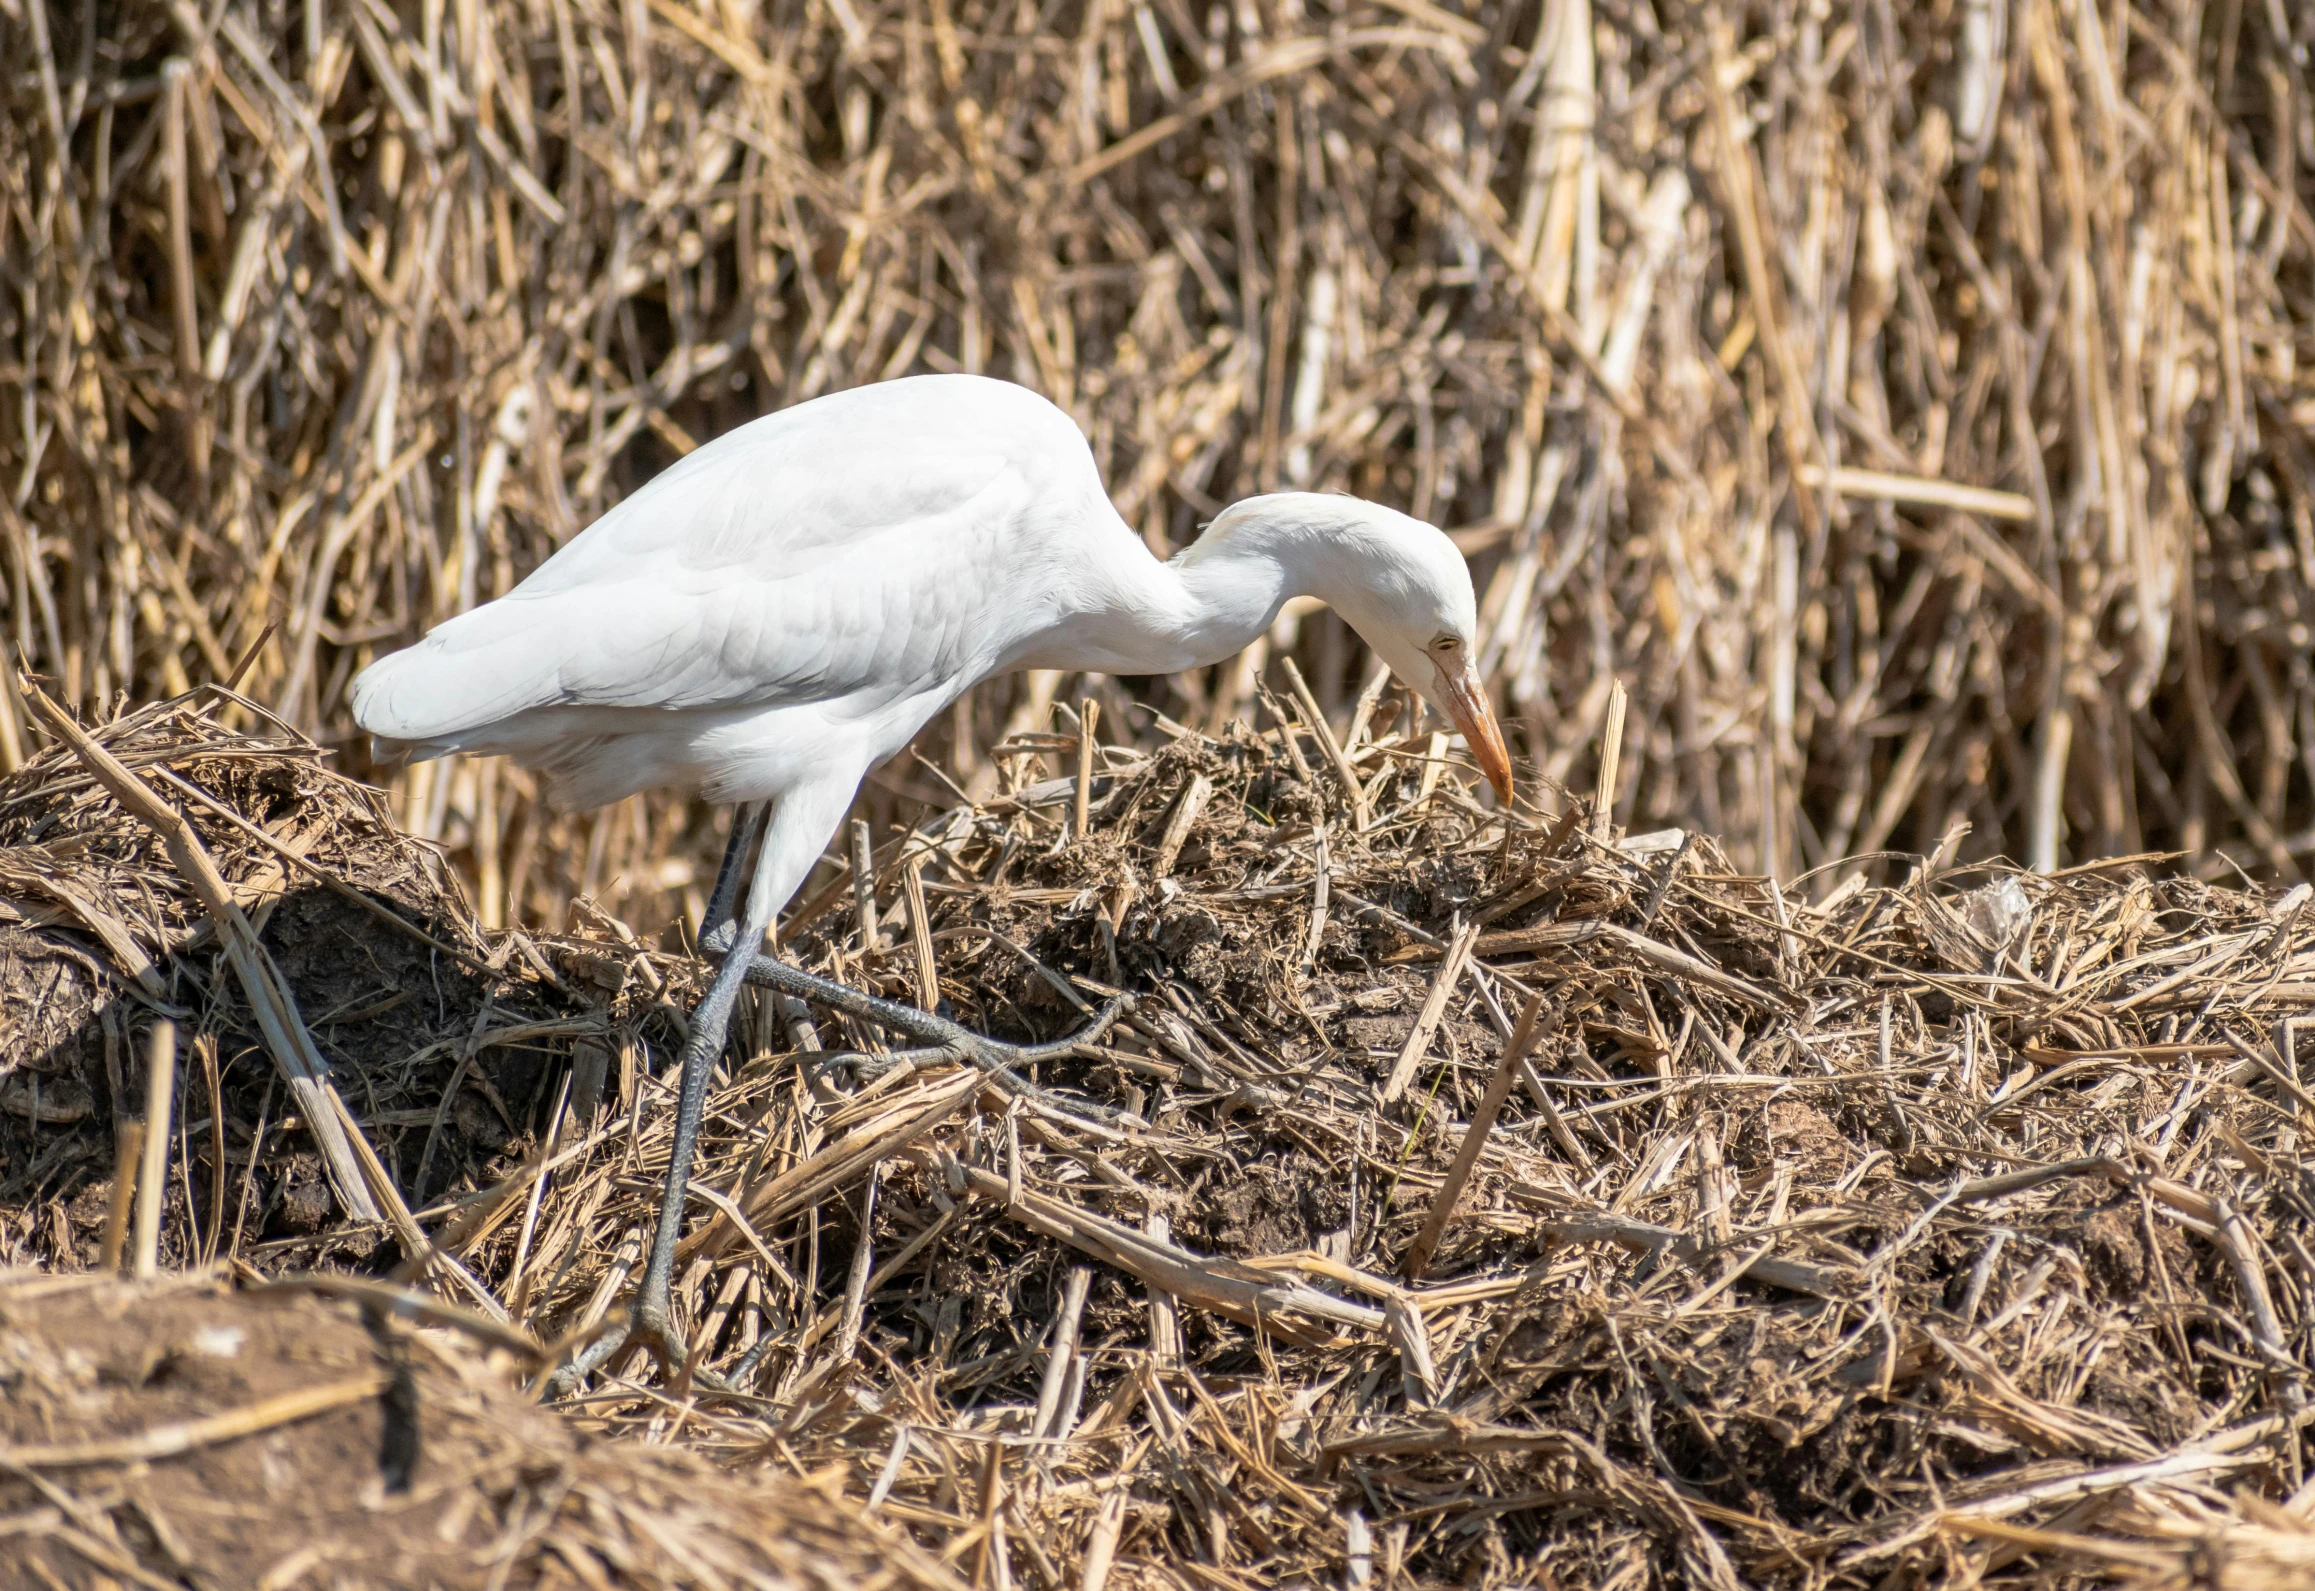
[0, 1274, 954, 1591]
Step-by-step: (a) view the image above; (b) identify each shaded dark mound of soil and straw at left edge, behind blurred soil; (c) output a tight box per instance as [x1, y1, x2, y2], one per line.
[0, 688, 604, 1264]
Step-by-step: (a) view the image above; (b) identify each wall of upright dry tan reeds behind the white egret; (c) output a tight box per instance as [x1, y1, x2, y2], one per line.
[0, 0, 2315, 926]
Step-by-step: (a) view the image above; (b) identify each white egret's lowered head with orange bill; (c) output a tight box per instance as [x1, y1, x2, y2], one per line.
[1213, 491, 1512, 804]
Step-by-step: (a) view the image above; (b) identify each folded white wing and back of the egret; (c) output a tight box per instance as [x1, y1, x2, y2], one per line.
[352, 377, 1100, 750]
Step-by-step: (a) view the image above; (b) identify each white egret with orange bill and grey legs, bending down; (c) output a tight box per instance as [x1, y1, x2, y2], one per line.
[352, 375, 1512, 1348]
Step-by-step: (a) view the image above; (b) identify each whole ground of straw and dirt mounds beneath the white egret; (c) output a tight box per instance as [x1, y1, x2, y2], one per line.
[0, 692, 2315, 1589]
